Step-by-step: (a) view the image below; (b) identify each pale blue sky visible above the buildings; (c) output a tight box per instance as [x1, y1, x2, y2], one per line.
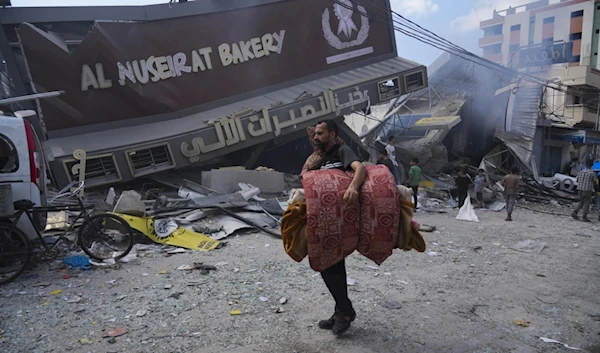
[12, 0, 558, 65]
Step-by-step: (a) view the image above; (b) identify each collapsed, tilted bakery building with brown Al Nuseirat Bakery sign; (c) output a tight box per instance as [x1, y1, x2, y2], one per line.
[0, 0, 427, 187]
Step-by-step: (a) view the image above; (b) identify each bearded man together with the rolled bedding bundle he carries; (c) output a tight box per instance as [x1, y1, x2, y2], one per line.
[281, 121, 426, 336]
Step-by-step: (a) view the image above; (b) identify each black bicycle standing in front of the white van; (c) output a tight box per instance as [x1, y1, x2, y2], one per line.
[0, 182, 135, 285]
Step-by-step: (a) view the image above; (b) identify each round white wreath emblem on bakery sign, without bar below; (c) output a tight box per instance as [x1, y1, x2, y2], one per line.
[321, 0, 369, 50]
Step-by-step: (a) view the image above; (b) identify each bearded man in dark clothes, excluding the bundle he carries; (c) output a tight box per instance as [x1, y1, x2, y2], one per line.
[313, 120, 367, 335]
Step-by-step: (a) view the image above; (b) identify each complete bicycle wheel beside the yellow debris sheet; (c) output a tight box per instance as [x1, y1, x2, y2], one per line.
[78, 213, 134, 260]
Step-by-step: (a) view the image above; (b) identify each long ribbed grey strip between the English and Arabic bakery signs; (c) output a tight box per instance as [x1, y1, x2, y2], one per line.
[45, 57, 422, 157]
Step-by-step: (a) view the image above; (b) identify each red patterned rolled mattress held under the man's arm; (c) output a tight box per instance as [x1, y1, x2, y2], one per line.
[302, 165, 400, 272]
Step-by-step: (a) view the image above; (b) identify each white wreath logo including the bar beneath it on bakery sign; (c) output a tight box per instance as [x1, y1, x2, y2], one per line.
[321, 0, 373, 64]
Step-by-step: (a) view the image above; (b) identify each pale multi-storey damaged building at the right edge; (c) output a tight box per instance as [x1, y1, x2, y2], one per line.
[479, 0, 600, 177]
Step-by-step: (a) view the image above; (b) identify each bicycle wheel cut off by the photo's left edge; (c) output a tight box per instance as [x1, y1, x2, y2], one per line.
[0, 223, 31, 285]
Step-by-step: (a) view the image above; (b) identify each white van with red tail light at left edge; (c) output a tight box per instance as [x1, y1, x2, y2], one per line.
[0, 111, 47, 239]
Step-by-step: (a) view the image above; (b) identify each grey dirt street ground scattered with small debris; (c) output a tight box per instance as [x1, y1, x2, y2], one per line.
[0, 204, 600, 353]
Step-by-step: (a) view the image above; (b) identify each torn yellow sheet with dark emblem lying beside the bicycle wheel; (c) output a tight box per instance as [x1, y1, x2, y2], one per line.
[114, 213, 219, 251]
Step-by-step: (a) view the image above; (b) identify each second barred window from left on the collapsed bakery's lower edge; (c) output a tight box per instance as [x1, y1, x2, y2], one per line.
[126, 144, 175, 177]
